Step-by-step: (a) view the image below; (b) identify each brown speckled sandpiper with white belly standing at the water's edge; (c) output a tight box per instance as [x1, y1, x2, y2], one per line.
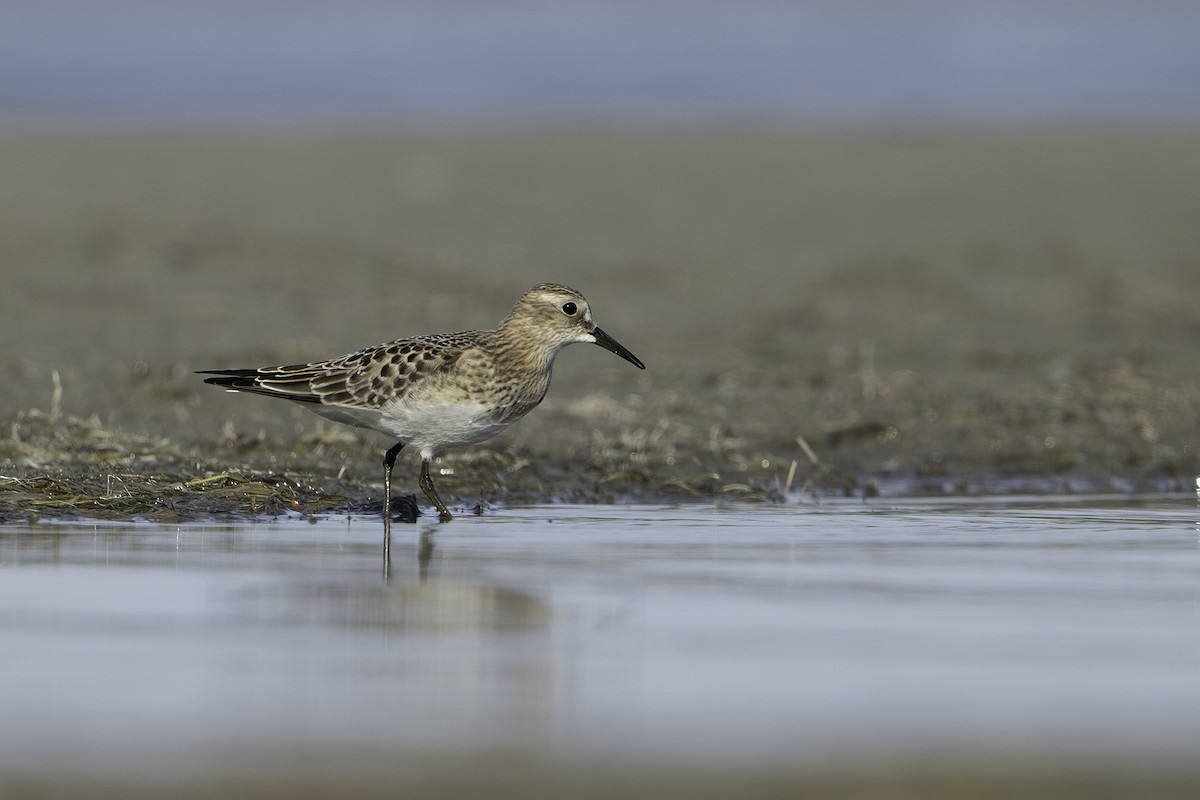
[200, 283, 646, 522]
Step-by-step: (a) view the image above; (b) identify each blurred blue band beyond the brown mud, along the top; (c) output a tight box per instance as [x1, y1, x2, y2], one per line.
[0, 0, 1200, 130]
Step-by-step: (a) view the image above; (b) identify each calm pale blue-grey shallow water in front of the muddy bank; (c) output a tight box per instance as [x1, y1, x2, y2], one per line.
[0, 495, 1200, 791]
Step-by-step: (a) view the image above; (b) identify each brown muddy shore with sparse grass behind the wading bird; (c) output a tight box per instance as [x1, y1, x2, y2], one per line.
[0, 128, 1200, 519]
